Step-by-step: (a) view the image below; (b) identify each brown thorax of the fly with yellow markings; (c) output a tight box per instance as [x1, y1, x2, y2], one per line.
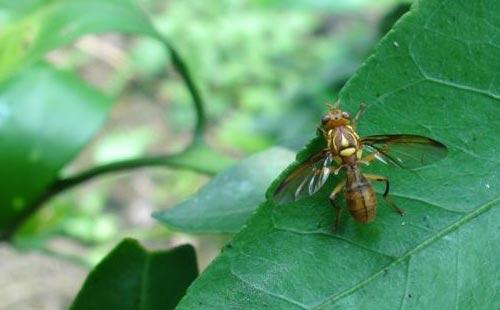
[328, 125, 362, 163]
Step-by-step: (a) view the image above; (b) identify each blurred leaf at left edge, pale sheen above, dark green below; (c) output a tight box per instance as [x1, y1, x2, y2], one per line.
[0, 64, 112, 235]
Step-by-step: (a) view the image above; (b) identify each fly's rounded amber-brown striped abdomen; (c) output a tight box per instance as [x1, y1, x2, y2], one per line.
[345, 167, 376, 223]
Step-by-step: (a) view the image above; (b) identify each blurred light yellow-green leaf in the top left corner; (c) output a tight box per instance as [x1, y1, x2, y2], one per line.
[0, 0, 159, 79]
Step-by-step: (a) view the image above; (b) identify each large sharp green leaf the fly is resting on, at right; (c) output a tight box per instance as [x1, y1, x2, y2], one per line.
[179, 0, 500, 309]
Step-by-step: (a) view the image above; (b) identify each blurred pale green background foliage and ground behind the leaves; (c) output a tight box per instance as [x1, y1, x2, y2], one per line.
[0, 0, 408, 308]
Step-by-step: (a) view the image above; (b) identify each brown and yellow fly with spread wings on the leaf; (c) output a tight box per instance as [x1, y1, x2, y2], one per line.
[273, 101, 447, 233]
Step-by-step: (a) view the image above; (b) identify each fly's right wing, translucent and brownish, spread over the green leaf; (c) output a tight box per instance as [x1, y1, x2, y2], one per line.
[361, 135, 448, 169]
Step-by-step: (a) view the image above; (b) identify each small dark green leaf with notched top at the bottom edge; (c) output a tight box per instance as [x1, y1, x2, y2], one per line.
[71, 239, 198, 310]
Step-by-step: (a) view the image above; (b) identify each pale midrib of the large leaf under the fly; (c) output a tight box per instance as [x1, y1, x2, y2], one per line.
[310, 196, 500, 309]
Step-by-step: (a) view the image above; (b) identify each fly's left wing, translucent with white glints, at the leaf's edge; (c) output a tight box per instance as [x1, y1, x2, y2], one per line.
[273, 150, 333, 204]
